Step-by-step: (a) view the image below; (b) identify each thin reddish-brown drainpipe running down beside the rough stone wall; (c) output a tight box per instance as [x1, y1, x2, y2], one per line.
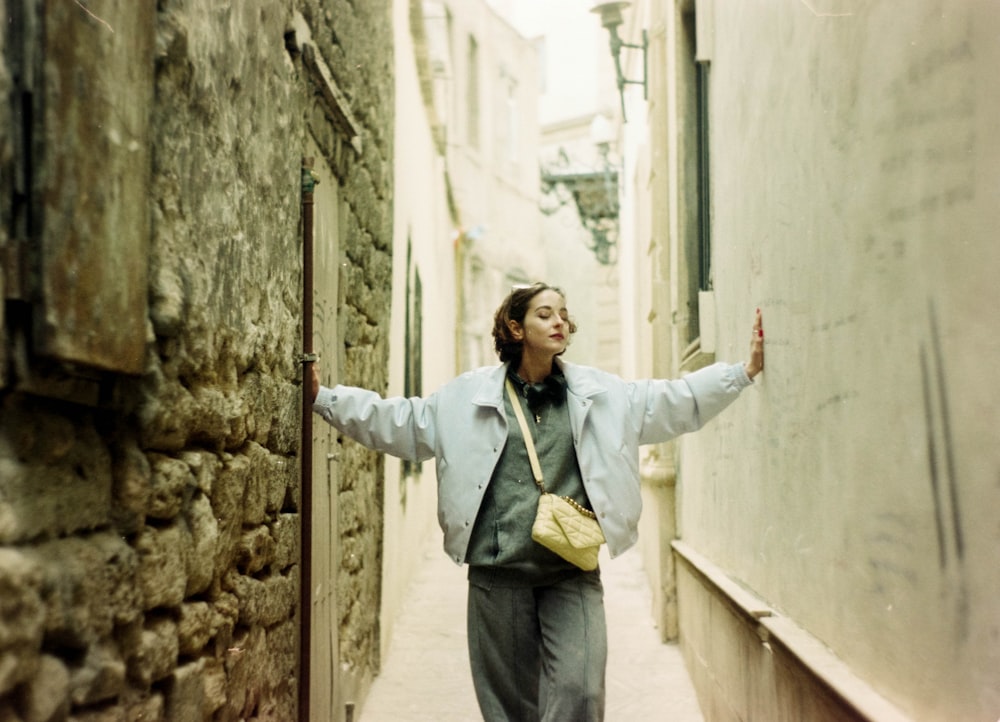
[299, 158, 319, 720]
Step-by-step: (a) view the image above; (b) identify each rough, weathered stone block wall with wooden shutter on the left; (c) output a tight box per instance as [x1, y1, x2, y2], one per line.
[0, 0, 393, 722]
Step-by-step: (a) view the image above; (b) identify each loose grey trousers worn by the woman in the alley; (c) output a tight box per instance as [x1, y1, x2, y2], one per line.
[468, 571, 608, 722]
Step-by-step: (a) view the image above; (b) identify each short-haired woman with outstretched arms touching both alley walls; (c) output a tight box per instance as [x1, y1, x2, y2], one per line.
[312, 283, 764, 722]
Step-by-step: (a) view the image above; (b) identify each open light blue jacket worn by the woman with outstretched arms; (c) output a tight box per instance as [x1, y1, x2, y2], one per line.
[313, 359, 751, 564]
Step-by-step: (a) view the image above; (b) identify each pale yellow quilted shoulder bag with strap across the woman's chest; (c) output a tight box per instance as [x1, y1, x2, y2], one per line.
[507, 379, 604, 572]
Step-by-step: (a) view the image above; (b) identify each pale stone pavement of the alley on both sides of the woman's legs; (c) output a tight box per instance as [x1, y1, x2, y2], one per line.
[358, 535, 704, 722]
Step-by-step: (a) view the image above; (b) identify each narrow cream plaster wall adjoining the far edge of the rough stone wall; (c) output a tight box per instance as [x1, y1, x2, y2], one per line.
[381, 0, 458, 668]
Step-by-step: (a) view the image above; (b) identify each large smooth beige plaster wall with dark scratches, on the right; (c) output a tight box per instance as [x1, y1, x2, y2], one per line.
[680, 0, 1000, 720]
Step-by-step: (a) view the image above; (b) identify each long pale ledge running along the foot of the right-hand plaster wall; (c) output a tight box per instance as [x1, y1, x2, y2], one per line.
[671, 540, 912, 722]
